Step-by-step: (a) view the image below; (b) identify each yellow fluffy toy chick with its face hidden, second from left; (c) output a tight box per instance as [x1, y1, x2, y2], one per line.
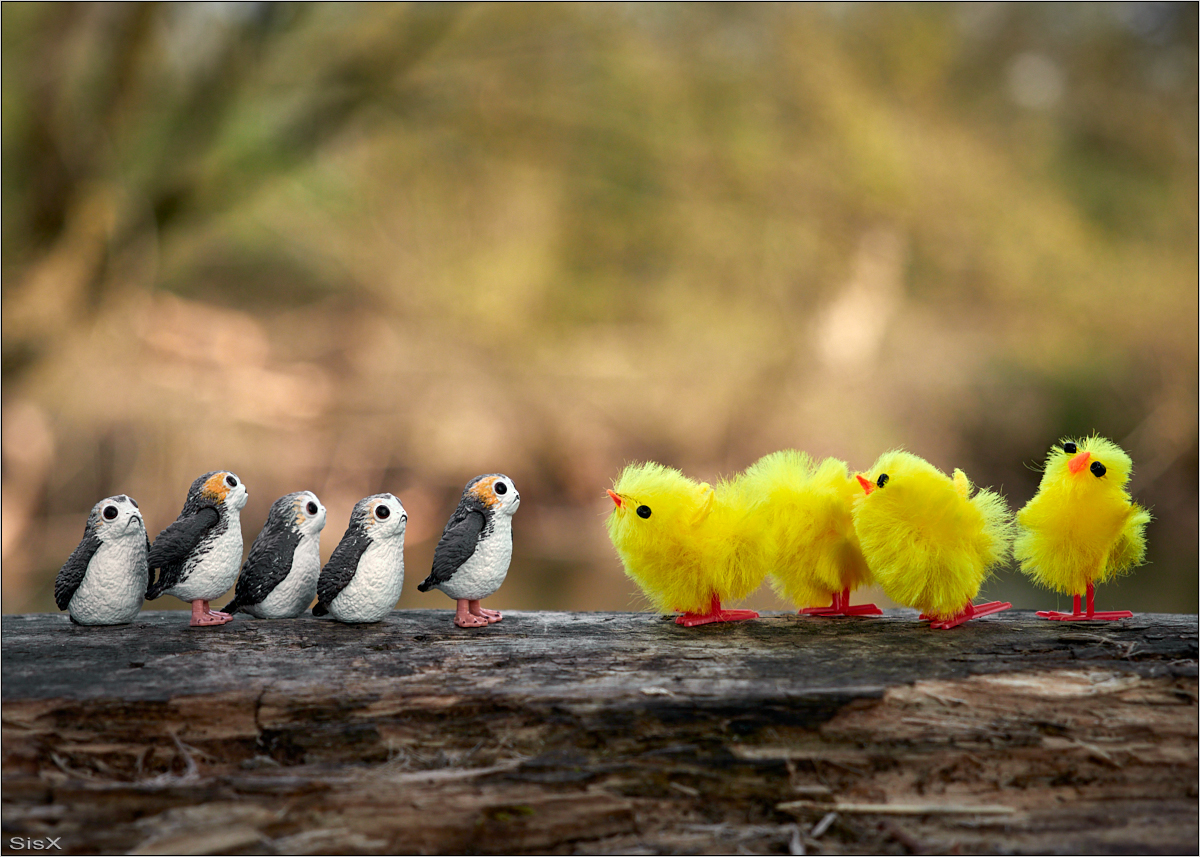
[743, 449, 882, 616]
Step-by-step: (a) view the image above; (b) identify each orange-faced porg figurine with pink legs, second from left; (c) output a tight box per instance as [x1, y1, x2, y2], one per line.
[146, 471, 247, 627]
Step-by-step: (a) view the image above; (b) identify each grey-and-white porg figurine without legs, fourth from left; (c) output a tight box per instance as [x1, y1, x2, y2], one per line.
[312, 493, 408, 624]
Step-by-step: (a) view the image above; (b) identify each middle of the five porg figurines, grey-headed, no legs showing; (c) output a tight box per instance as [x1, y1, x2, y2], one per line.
[221, 491, 325, 619]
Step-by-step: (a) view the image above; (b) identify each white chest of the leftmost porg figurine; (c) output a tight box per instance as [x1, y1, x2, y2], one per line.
[67, 528, 150, 625]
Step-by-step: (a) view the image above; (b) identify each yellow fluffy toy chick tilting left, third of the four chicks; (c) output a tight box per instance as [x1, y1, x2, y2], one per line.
[853, 450, 1013, 629]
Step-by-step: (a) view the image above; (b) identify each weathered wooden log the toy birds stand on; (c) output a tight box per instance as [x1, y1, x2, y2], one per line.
[2, 611, 1198, 853]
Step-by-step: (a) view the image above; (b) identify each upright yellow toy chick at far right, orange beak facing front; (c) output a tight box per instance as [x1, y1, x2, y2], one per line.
[1013, 437, 1151, 621]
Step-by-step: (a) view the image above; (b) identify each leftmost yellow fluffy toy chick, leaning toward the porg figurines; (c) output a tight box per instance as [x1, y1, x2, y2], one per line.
[606, 462, 766, 628]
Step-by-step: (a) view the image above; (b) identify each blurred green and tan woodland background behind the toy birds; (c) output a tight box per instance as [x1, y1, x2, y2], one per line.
[0, 2, 1200, 612]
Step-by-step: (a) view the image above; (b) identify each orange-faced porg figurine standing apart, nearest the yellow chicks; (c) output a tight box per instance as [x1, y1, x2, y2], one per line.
[416, 473, 521, 628]
